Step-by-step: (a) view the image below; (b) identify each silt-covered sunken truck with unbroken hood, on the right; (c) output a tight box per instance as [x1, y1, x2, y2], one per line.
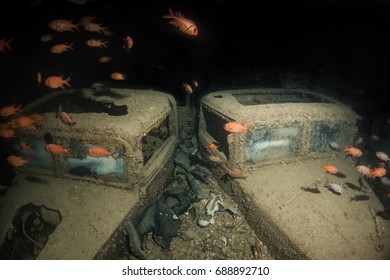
[199, 88, 390, 259]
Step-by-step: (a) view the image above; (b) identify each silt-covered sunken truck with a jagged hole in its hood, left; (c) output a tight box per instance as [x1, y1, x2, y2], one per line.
[0, 88, 178, 259]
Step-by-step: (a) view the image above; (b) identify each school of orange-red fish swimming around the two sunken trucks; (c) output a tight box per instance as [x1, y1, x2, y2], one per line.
[0, 4, 390, 208]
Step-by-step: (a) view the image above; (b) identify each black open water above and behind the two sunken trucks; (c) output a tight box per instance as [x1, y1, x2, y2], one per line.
[0, 0, 390, 187]
